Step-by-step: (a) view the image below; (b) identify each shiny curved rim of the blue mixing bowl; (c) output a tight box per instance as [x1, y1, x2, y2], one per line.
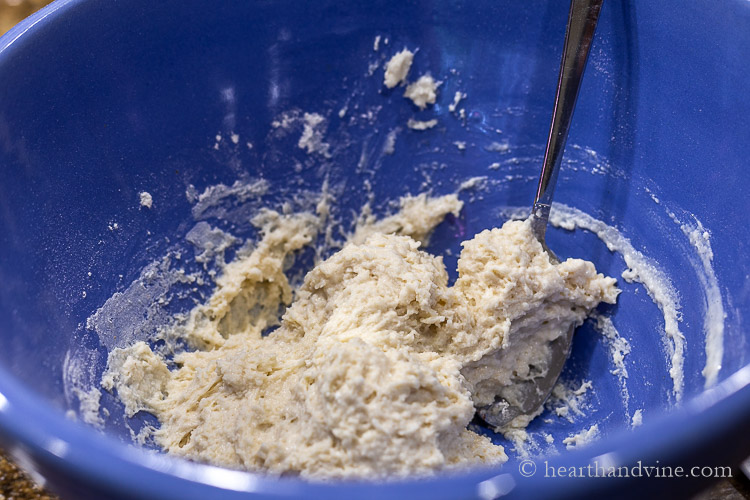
[0, 0, 750, 499]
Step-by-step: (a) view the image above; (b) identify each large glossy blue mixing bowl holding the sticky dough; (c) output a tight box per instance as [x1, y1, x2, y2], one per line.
[0, 0, 750, 499]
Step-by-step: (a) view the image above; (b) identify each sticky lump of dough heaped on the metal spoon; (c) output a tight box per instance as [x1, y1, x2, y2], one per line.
[455, 220, 619, 427]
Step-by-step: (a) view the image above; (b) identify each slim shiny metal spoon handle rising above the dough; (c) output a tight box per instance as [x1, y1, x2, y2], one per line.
[531, 0, 603, 241]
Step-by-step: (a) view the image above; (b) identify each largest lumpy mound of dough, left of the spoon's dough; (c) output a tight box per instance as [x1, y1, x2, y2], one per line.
[156, 234, 506, 478]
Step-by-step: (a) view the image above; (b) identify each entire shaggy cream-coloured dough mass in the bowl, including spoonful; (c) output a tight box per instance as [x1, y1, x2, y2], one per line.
[103, 210, 618, 479]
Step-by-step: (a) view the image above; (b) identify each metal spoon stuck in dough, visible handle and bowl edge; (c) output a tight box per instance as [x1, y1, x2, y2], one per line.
[477, 0, 603, 427]
